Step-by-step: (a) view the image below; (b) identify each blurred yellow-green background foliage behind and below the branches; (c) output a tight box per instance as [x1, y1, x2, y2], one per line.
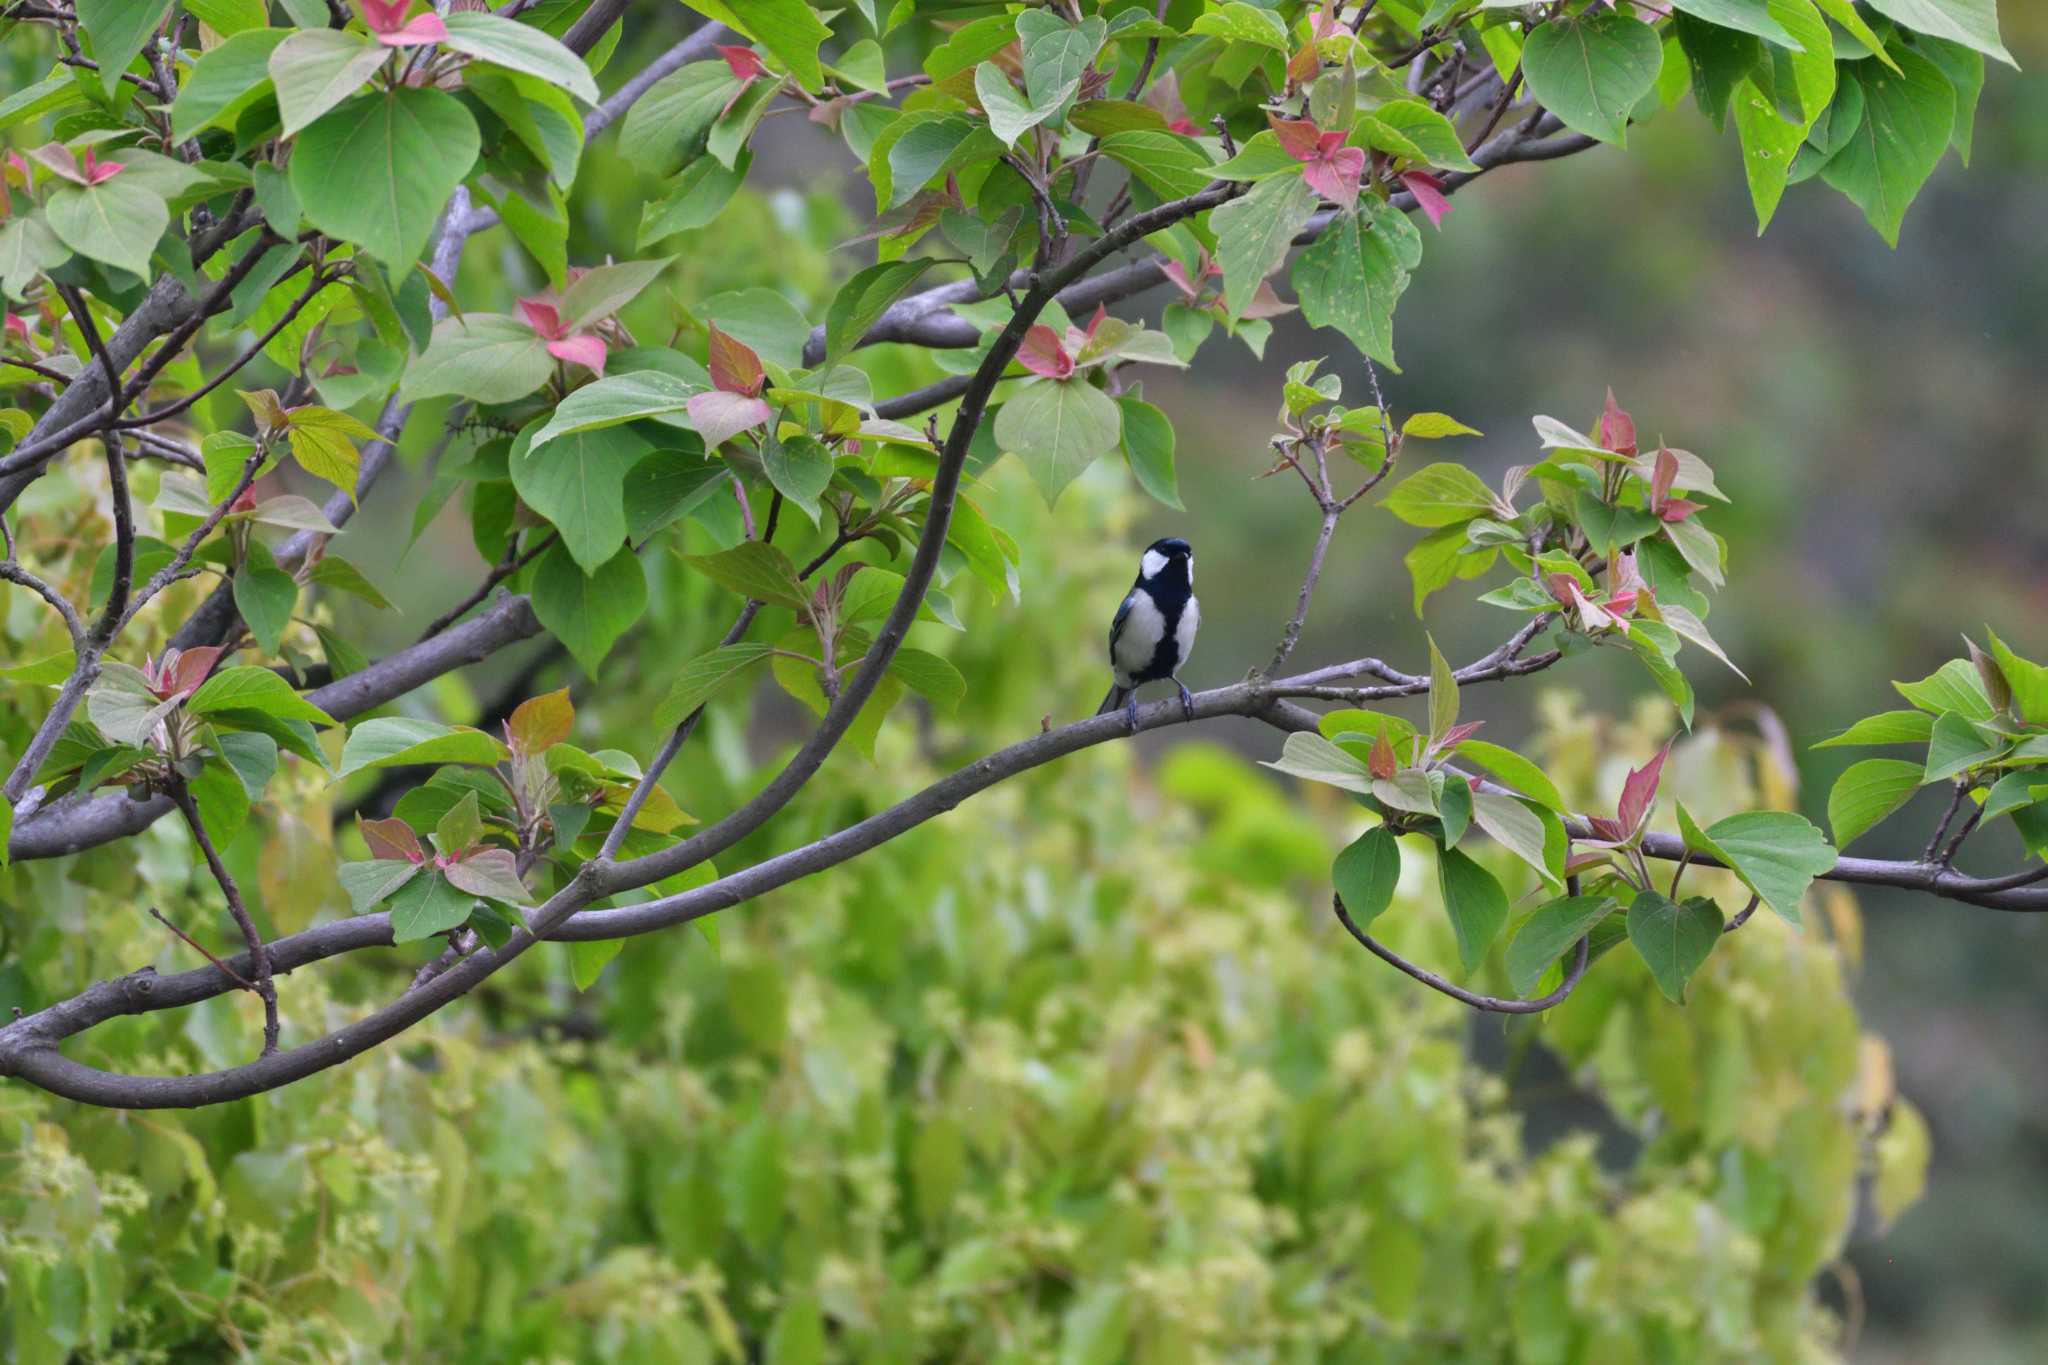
[0, 473, 1915, 1365]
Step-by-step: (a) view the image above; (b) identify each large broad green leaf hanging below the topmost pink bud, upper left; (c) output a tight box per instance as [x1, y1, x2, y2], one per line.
[292, 87, 481, 270]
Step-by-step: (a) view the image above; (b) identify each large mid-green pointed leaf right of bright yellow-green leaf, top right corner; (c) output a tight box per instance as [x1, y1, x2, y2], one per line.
[1821, 47, 1956, 246]
